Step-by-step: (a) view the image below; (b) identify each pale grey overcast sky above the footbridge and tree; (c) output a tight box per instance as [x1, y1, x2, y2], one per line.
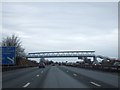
[2, 2, 118, 62]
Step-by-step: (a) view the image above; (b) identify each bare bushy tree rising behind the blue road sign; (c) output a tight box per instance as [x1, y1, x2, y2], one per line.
[2, 34, 25, 57]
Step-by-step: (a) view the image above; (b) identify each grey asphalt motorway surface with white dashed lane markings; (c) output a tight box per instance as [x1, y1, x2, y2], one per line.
[2, 65, 119, 88]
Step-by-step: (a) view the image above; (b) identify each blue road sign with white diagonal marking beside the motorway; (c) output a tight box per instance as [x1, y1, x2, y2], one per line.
[2, 47, 16, 65]
